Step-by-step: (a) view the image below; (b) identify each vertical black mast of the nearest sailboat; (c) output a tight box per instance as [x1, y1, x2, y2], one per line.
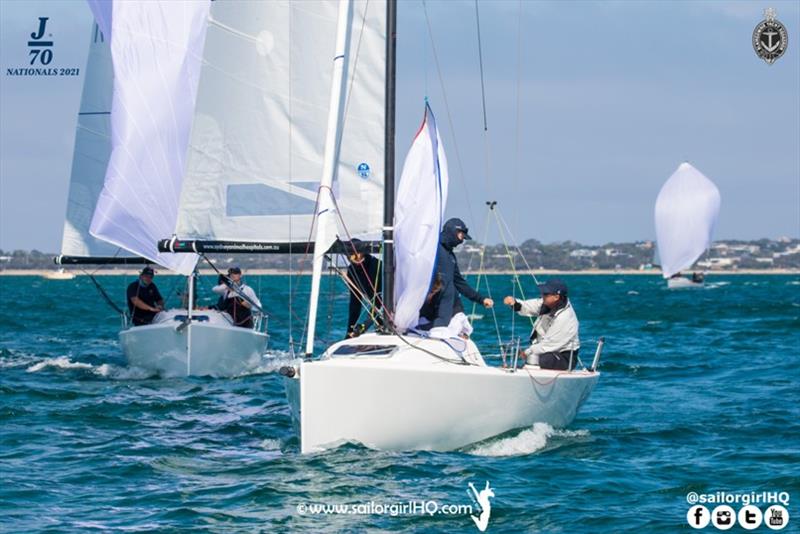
[382, 0, 397, 325]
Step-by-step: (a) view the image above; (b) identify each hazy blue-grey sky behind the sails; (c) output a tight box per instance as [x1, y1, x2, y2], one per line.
[0, 0, 800, 252]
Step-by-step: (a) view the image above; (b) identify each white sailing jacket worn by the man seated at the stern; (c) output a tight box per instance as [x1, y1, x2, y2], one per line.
[515, 299, 581, 356]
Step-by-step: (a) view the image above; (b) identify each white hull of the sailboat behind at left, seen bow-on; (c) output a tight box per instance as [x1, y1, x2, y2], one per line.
[119, 310, 268, 377]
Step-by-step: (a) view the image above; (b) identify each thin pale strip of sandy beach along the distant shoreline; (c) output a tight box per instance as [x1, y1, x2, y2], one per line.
[0, 268, 800, 277]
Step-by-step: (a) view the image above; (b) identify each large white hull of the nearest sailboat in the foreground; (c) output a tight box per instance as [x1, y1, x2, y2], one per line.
[285, 334, 599, 453]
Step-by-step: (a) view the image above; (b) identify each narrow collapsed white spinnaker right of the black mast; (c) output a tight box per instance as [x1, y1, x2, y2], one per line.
[394, 104, 449, 332]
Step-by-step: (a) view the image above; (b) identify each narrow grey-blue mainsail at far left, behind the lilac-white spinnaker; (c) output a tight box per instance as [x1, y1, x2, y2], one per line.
[61, 24, 127, 256]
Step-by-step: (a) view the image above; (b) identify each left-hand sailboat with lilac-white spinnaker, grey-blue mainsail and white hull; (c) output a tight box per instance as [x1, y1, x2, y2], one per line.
[56, 6, 268, 376]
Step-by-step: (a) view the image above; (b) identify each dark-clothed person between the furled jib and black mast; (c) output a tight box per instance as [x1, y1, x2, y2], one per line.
[344, 239, 381, 337]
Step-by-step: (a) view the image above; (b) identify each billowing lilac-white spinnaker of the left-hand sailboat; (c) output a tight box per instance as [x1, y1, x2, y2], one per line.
[90, 0, 210, 274]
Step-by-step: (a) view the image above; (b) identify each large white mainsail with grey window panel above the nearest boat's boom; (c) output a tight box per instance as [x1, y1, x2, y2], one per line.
[175, 0, 386, 242]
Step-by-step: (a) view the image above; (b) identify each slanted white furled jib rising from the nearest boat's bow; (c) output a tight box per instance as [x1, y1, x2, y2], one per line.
[305, 0, 352, 359]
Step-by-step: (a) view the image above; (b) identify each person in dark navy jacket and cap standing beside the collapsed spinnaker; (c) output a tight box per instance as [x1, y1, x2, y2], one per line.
[433, 219, 494, 328]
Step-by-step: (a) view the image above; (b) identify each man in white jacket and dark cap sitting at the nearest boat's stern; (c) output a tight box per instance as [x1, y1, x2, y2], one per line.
[503, 278, 581, 370]
